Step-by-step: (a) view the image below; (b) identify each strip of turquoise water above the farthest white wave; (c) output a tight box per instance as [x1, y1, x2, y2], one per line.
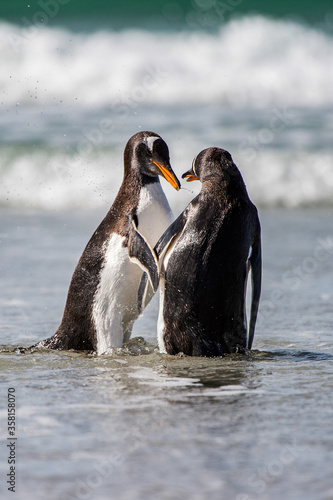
[0, 0, 332, 28]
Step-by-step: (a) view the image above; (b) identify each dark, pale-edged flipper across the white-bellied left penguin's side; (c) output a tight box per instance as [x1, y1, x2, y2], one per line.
[127, 218, 159, 292]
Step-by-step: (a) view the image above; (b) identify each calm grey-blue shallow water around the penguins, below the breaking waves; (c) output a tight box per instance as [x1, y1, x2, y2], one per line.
[0, 210, 333, 500]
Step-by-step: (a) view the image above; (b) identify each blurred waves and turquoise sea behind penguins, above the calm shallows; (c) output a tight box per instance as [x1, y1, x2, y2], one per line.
[0, 0, 333, 211]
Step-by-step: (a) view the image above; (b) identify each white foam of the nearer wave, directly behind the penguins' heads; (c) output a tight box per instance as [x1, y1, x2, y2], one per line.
[0, 146, 333, 210]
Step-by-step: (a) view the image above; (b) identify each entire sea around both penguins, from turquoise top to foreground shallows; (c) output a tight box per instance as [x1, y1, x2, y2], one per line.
[0, 0, 333, 500]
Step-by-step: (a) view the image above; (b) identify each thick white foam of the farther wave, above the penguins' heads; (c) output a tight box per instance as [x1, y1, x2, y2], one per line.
[0, 16, 333, 106]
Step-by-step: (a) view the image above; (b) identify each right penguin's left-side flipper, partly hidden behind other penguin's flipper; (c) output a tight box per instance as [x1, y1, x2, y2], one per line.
[138, 211, 187, 314]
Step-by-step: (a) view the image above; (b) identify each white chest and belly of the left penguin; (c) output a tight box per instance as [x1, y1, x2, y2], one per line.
[92, 182, 172, 354]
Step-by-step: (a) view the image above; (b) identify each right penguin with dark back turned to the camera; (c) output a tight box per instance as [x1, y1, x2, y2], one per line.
[139, 148, 261, 356]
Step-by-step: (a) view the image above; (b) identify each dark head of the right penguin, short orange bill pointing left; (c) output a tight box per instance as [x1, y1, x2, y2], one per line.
[182, 148, 243, 185]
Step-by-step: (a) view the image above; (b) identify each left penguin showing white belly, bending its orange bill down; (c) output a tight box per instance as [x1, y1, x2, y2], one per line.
[35, 132, 180, 354]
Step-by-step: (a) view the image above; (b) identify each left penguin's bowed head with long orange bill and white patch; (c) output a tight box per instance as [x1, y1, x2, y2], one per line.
[124, 131, 180, 191]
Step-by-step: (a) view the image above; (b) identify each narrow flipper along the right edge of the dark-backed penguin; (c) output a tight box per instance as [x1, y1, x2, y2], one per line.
[248, 239, 261, 349]
